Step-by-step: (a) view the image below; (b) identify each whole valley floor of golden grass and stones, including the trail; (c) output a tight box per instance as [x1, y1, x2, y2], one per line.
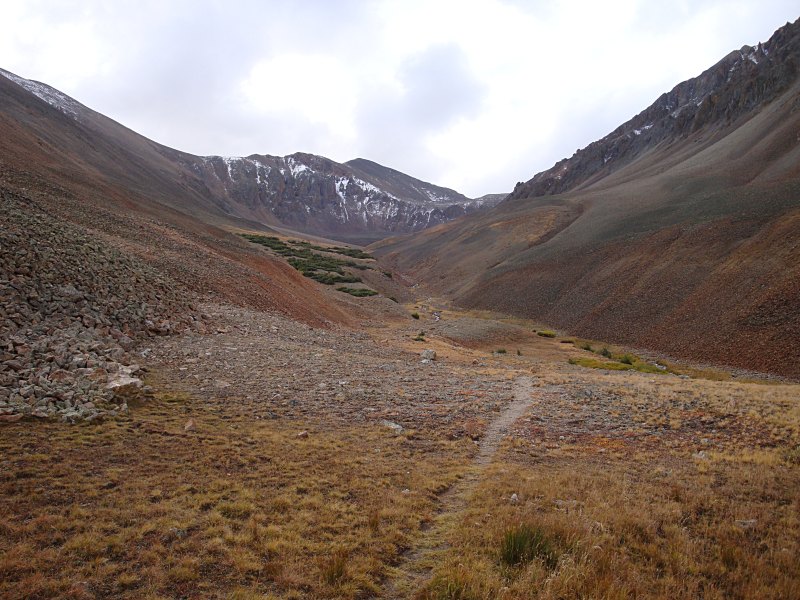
[0, 299, 800, 599]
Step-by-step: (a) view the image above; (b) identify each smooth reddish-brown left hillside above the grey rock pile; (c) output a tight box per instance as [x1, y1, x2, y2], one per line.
[0, 77, 348, 332]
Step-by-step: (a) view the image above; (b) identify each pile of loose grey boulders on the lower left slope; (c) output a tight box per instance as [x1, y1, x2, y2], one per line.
[0, 190, 204, 421]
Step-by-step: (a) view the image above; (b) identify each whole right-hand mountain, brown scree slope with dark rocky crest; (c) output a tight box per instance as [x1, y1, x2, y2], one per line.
[373, 20, 800, 377]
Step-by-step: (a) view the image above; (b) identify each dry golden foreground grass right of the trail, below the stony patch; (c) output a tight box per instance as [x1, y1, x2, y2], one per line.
[419, 455, 800, 599]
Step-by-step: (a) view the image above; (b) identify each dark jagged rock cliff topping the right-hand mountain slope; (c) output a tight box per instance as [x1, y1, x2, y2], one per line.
[511, 19, 800, 198]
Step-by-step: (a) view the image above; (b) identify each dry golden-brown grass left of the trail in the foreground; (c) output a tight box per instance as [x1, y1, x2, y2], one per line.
[0, 397, 472, 598]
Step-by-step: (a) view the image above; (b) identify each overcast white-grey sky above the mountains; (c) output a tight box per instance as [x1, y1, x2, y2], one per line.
[0, 0, 800, 197]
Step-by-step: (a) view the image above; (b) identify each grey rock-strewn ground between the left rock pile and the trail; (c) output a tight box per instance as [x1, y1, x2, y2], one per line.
[147, 305, 512, 436]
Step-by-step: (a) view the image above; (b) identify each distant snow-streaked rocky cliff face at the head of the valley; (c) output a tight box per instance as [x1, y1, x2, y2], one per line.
[184, 153, 499, 237]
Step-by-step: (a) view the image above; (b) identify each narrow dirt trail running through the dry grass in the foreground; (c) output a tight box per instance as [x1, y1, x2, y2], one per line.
[383, 376, 550, 600]
